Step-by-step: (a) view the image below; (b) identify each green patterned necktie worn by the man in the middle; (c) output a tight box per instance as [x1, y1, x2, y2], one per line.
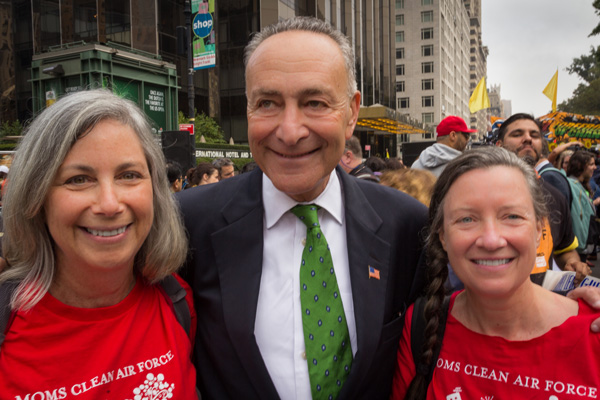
[291, 204, 352, 399]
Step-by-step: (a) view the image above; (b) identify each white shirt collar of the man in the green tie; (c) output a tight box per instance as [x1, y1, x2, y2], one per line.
[262, 169, 344, 229]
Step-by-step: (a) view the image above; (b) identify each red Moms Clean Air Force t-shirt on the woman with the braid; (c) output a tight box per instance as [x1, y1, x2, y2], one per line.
[392, 293, 600, 400]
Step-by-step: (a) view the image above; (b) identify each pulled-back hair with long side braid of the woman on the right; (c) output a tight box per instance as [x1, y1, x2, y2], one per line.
[405, 146, 547, 400]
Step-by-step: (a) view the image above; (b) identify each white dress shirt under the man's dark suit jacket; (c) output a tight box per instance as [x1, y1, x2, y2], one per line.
[254, 170, 357, 400]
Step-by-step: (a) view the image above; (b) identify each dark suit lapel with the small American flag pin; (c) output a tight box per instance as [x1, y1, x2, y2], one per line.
[338, 170, 390, 398]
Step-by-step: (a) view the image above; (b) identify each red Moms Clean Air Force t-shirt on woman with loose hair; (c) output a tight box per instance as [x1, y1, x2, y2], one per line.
[0, 280, 197, 400]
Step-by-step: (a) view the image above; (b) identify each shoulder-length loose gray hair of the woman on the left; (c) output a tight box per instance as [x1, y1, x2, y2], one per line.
[0, 89, 187, 310]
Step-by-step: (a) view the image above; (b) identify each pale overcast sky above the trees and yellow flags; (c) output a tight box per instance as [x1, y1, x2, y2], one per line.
[481, 0, 600, 117]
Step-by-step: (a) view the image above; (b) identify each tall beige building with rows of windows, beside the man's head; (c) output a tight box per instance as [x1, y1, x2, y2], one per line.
[395, 0, 470, 139]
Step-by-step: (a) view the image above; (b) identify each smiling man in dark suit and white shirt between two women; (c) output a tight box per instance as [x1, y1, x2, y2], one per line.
[178, 18, 427, 399]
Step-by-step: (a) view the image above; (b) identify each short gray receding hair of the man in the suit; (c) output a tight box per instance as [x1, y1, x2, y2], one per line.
[244, 17, 357, 97]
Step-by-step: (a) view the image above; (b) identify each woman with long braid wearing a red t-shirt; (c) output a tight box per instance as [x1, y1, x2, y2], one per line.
[392, 147, 600, 400]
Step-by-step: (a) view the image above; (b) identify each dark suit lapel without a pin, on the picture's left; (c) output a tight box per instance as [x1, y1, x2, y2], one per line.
[211, 171, 279, 398]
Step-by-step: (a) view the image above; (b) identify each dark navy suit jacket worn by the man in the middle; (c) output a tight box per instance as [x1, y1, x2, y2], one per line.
[177, 168, 427, 399]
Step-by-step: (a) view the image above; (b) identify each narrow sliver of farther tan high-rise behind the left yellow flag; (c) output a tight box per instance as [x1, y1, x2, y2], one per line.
[464, 0, 489, 139]
